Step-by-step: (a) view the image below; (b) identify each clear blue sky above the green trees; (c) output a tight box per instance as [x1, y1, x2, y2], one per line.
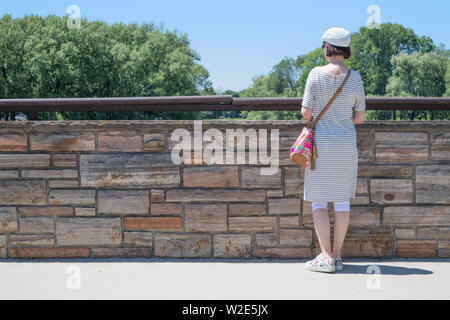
[0, 0, 450, 90]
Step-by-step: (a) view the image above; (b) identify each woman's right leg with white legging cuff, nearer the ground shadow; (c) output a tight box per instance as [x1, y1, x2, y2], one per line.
[332, 200, 350, 259]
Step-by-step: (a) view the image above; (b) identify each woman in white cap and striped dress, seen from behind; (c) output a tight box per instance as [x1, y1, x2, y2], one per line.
[301, 28, 366, 272]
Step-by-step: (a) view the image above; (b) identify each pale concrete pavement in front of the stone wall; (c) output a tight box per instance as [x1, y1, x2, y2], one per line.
[0, 259, 450, 300]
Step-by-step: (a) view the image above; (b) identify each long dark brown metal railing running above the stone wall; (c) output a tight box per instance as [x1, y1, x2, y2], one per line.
[0, 95, 450, 120]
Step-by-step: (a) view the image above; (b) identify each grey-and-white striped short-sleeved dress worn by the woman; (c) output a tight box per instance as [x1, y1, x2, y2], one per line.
[302, 67, 366, 202]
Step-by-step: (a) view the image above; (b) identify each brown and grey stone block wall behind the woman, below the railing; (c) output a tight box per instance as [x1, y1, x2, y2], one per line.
[0, 121, 450, 259]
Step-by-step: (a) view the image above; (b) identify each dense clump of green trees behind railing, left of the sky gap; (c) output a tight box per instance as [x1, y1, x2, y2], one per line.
[0, 14, 214, 119]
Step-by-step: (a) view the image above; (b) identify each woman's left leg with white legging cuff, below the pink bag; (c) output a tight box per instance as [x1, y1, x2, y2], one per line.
[312, 202, 332, 259]
